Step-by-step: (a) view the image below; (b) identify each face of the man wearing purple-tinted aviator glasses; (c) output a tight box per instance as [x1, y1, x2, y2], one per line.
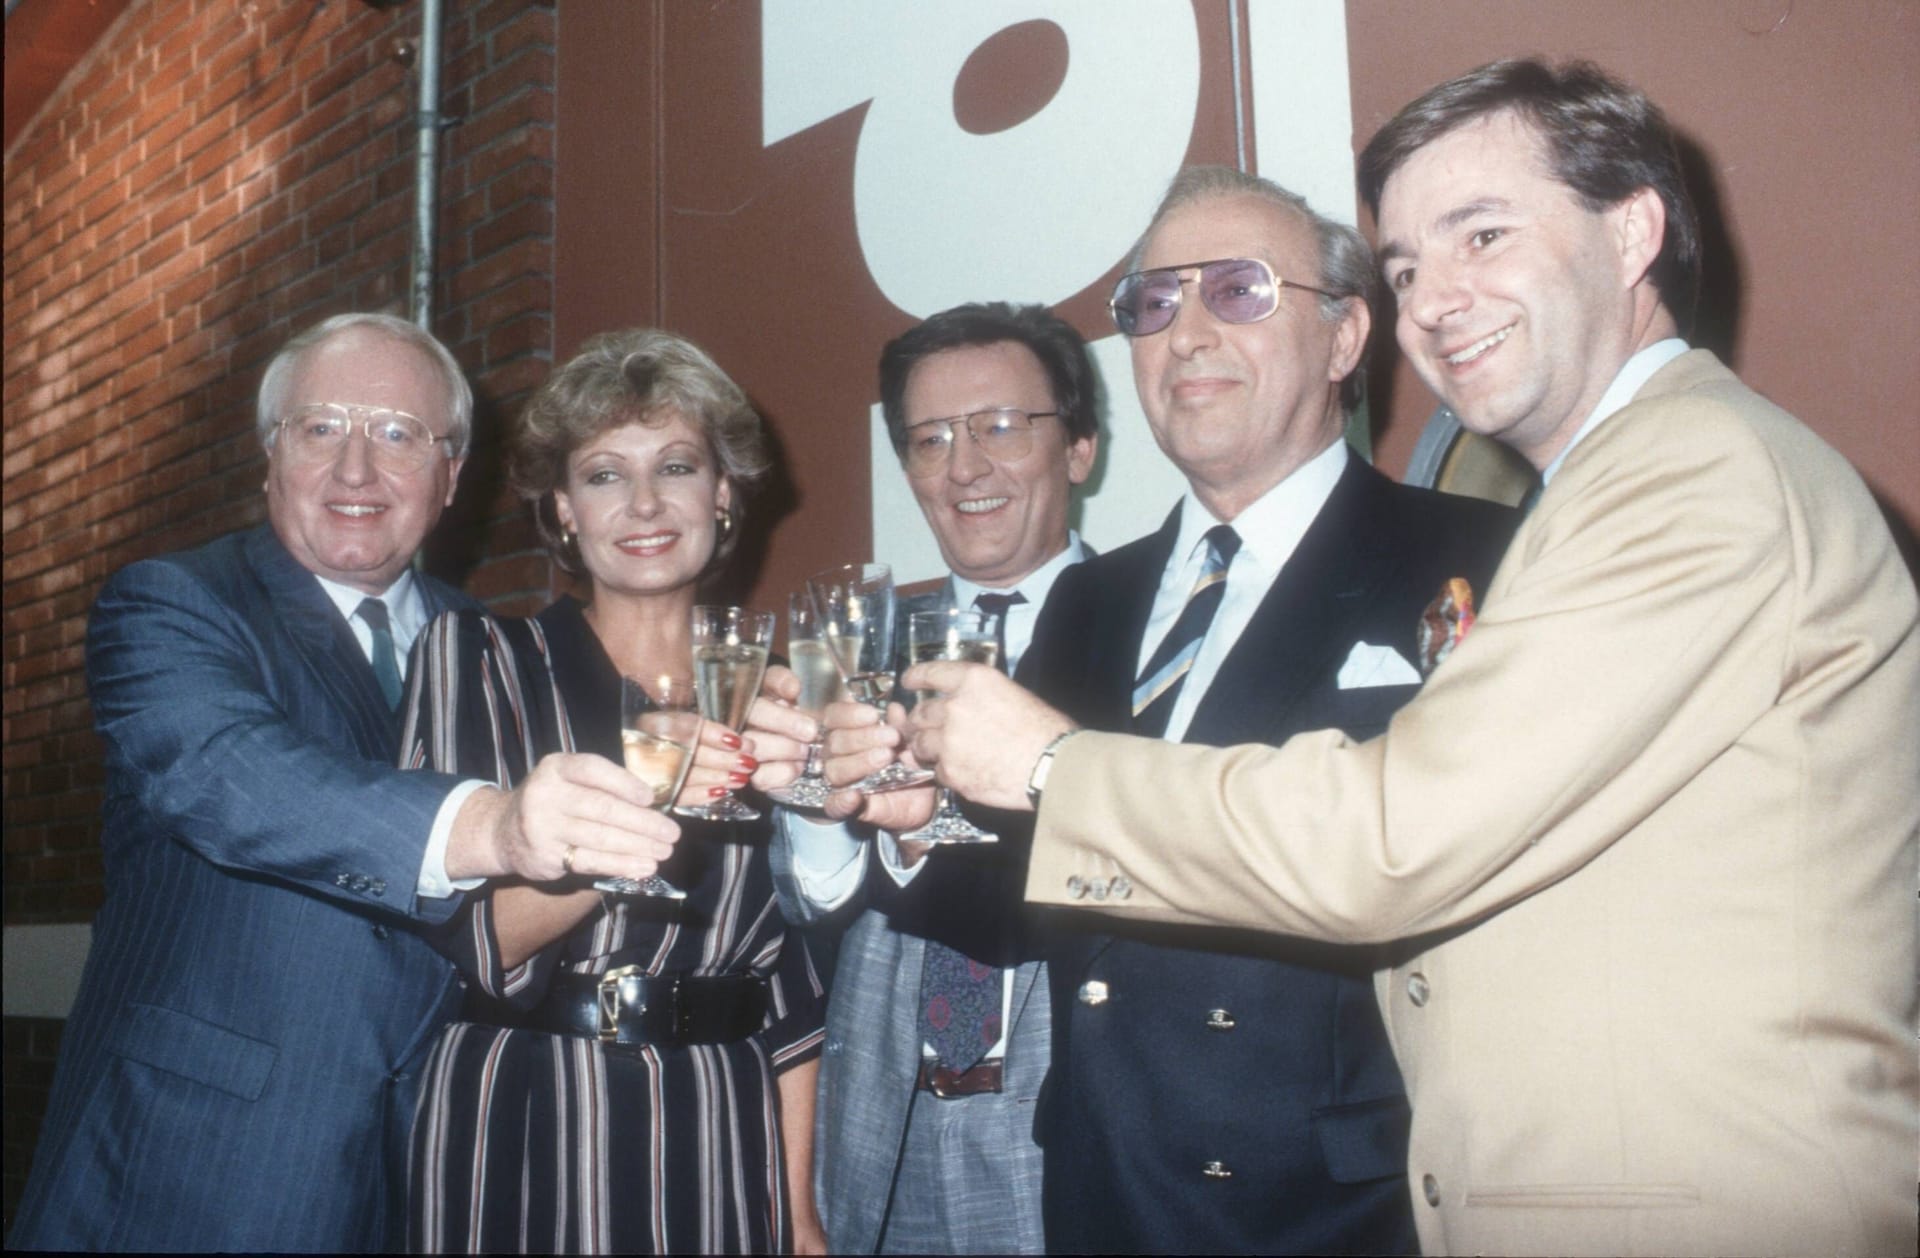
[1133, 194, 1369, 520]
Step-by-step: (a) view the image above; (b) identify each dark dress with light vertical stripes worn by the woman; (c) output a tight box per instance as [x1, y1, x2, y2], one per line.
[401, 599, 826, 1254]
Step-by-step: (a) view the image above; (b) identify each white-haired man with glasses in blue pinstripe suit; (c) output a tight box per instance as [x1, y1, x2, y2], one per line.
[8, 315, 678, 1250]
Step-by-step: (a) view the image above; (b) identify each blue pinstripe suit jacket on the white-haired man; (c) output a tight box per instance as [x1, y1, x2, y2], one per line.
[8, 526, 470, 1250]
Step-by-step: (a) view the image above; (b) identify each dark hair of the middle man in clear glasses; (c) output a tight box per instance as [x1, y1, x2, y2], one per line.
[879, 302, 1100, 455]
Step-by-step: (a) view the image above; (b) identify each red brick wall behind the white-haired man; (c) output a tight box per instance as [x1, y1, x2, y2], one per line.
[0, 0, 555, 1220]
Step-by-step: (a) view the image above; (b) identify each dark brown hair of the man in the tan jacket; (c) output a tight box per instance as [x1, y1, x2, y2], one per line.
[1359, 58, 1699, 332]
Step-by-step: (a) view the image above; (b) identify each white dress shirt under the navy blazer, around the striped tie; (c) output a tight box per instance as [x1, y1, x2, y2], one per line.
[1133, 440, 1348, 743]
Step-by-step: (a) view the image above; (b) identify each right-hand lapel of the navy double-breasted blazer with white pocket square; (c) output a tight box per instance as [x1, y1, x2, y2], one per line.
[1185, 459, 1394, 747]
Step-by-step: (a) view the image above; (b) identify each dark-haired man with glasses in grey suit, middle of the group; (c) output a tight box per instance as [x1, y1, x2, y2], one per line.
[768, 303, 1098, 1254]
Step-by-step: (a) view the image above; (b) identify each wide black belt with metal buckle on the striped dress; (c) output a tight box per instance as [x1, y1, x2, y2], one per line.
[534, 966, 766, 1045]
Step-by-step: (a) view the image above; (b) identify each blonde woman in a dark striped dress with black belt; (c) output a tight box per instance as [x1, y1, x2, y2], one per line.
[401, 330, 824, 1254]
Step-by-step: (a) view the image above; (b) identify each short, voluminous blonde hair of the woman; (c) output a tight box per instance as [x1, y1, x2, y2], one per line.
[507, 328, 772, 572]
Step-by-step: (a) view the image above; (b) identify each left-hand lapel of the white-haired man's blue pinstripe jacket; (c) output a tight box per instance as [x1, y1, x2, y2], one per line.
[246, 526, 397, 761]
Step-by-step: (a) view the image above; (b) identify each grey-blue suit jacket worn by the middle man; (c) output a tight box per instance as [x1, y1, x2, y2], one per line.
[772, 582, 1050, 1254]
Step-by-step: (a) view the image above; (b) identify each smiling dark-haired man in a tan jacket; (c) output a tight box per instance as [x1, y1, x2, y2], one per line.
[904, 61, 1920, 1254]
